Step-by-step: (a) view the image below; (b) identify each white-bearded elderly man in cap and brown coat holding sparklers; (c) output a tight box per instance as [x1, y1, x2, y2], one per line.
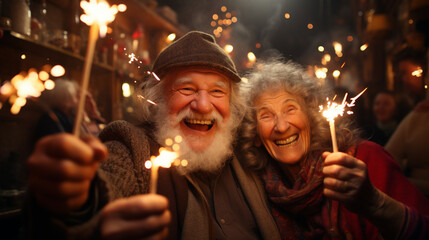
[28, 31, 279, 239]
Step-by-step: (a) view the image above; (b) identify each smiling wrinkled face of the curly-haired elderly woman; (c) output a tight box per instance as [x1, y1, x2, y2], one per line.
[254, 89, 310, 164]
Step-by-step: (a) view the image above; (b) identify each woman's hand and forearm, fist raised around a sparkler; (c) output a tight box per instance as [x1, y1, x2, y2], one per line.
[323, 152, 405, 239]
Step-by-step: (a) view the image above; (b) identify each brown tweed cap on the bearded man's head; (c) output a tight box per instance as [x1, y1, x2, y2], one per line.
[152, 31, 240, 82]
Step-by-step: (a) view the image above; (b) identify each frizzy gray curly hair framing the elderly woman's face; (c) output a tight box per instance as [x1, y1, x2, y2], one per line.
[239, 59, 358, 170]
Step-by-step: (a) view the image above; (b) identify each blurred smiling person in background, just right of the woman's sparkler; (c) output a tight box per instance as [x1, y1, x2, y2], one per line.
[363, 90, 400, 146]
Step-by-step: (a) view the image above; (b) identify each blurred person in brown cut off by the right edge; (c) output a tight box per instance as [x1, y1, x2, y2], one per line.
[386, 100, 429, 197]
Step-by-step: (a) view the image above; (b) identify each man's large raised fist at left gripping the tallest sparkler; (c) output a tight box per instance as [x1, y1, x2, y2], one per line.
[27, 133, 107, 213]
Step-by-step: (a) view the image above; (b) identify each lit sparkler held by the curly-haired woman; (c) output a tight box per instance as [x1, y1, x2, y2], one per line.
[319, 88, 366, 152]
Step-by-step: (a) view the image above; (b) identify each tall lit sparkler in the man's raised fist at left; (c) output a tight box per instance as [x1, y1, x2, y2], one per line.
[73, 0, 125, 136]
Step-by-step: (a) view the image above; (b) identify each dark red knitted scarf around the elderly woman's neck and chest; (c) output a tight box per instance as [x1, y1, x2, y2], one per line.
[262, 156, 350, 239]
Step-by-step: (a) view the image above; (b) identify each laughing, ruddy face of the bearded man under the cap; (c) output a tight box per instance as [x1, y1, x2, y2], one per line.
[166, 68, 231, 152]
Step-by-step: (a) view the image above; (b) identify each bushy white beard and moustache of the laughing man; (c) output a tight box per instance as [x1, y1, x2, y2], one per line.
[155, 103, 238, 175]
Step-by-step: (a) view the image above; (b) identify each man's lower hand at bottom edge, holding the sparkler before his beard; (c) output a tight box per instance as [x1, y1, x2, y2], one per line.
[100, 194, 171, 240]
